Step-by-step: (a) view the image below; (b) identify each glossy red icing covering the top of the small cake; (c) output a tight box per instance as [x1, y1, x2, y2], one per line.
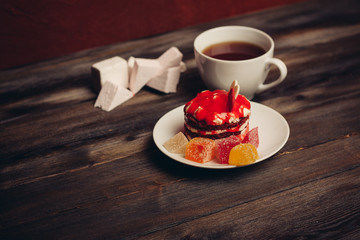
[184, 90, 250, 125]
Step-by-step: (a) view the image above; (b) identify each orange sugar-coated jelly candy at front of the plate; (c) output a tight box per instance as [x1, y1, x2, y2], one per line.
[185, 137, 216, 163]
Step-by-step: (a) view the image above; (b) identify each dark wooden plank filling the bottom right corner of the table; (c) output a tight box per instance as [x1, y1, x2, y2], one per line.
[138, 168, 360, 239]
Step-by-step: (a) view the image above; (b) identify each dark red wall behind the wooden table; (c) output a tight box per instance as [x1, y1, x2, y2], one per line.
[0, 0, 300, 69]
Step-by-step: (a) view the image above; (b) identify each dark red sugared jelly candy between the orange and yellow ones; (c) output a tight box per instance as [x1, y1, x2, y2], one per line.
[215, 135, 241, 164]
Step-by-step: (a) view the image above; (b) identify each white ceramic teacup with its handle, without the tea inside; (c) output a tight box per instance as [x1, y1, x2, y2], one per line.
[194, 26, 287, 99]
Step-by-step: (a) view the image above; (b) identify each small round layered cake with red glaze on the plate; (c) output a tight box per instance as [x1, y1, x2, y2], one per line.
[184, 81, 251, 140]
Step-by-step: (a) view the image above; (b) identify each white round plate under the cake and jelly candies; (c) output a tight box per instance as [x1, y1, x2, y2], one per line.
[153, 102, 290, 169]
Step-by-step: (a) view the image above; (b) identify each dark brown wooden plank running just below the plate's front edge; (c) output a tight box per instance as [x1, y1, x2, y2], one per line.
[1, 132, 360, 238]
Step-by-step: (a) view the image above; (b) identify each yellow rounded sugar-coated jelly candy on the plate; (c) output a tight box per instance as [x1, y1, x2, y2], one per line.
[229, 143, 259, 166]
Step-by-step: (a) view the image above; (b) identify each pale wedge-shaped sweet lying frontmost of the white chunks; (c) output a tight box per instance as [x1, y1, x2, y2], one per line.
[94, 81, 133, 112]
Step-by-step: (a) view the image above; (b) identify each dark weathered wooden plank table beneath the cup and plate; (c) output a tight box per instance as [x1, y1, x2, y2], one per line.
[0, 0, 360, 239]
